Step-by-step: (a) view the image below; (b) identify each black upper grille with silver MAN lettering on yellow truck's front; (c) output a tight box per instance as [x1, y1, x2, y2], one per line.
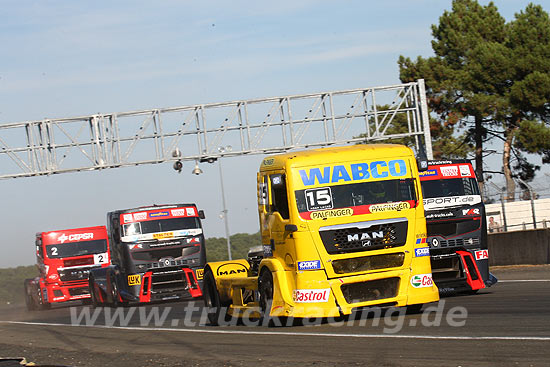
[319, 218, 408, 254]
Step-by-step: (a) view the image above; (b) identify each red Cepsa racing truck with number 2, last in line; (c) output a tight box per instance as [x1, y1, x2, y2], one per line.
[25, 226, 110, 310]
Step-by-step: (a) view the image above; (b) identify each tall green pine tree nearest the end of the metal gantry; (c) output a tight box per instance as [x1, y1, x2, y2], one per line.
[398, 0, 505, 194]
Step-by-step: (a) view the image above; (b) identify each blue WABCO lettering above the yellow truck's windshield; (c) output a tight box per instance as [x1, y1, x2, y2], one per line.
[299, 159, 408, 186]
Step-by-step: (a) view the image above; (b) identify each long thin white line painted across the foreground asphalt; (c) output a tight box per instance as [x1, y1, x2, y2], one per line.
[0, 321, 550, 341]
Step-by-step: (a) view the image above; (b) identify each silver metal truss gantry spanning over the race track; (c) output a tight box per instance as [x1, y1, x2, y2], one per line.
[0, 79, 432, 179]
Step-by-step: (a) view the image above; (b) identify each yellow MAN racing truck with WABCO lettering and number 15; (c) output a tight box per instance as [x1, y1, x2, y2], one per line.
[203, 144, 439, 324]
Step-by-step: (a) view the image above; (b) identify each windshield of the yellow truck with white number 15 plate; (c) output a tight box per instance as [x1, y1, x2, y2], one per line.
[295, 178, 416, 213]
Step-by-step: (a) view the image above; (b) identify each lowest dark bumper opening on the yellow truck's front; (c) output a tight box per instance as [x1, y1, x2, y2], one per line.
[340, 278, 400, 304]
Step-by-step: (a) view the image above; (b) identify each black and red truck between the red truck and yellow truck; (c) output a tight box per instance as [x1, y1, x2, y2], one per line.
[89, 204, 206, 306]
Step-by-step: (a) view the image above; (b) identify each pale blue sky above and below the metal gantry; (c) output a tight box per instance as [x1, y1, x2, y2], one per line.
[0, 0, 550, 267]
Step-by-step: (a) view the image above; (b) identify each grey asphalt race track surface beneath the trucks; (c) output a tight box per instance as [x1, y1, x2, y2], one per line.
[0, 266, 550, 366]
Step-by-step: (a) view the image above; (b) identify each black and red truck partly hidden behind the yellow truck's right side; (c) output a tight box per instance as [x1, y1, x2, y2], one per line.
[420, 159, 497, 293]
